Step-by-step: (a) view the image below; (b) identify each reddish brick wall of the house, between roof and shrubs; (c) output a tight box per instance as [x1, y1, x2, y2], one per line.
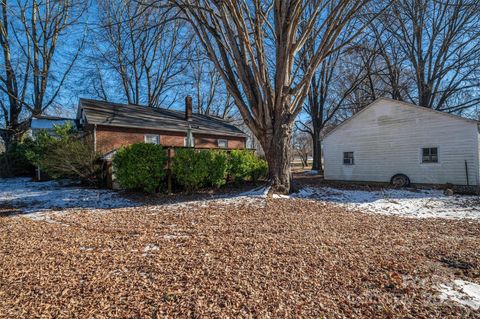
[96, 126, 245, 154]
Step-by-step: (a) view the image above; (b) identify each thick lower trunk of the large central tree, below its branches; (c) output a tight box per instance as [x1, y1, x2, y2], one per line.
[262, 124, 292, 194]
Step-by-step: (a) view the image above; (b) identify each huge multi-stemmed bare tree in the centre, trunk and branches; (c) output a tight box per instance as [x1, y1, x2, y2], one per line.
[170, 0, 386, 193]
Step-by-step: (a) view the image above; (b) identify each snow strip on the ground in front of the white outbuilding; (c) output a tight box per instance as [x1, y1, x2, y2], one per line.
[290, 187, 480, 219]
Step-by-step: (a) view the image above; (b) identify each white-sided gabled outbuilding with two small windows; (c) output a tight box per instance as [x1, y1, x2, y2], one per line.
[323, 98, 480, 185]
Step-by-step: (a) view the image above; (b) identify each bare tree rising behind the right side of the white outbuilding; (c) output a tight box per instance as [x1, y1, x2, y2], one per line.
[383, 0, 480, 112]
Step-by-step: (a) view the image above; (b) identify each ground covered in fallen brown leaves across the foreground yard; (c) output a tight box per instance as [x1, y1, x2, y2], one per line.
[0, 199, 480, 318]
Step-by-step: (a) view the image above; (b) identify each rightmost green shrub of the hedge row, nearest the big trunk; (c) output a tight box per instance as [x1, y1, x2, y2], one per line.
[228, 150, 268, 183]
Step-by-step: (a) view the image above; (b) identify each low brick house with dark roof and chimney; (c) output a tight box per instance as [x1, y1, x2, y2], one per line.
[77, 97, 247, 158]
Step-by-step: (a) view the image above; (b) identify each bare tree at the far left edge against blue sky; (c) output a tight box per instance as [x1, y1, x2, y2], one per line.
[0, 0, 86, 143]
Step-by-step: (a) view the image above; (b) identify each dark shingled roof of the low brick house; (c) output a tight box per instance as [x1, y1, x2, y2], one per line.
[78, 99, 246, 137]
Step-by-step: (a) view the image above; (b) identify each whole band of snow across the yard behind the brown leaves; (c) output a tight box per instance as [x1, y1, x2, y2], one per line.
[0, 178, 480, 219]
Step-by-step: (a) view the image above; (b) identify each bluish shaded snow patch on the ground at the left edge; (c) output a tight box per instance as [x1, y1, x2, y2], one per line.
[0, 178, 136, 213]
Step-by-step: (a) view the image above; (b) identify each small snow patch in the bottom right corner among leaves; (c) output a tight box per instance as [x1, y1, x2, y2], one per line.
[440, 279, 480, 310]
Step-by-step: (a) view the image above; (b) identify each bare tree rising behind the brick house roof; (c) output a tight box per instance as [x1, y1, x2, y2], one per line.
[91, 0, 192, 107]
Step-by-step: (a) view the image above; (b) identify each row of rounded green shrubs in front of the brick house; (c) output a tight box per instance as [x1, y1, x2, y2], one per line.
[113, 143, 267, 193]
